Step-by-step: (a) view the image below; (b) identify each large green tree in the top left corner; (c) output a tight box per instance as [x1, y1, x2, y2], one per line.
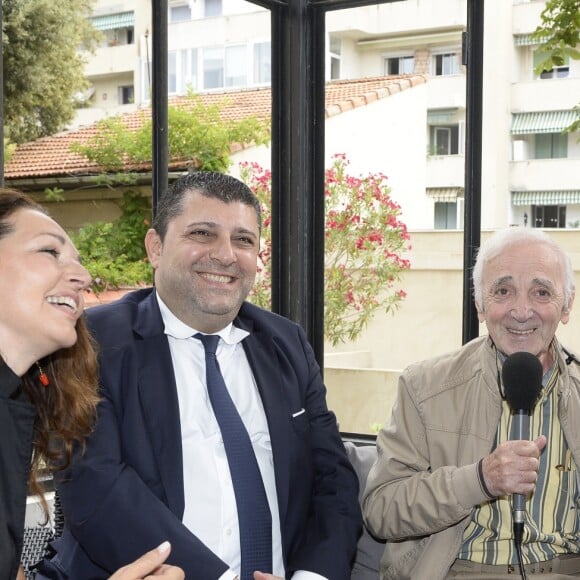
[2, 0, 99, 143]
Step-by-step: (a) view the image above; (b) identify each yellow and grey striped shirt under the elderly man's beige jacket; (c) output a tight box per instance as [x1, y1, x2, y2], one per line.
[458, 364, 580, 565]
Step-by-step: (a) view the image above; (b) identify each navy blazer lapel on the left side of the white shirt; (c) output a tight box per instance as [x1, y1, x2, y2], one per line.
[135, 292, 185, 518]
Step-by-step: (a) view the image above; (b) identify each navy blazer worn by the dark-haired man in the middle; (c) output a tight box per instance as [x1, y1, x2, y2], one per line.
[46, 289, 361, 580]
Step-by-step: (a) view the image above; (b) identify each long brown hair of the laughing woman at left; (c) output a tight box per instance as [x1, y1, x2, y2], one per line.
[0, 189, 98, 508]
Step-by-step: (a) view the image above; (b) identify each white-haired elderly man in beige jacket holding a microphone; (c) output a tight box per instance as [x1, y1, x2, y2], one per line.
[363, 228, 580, 580]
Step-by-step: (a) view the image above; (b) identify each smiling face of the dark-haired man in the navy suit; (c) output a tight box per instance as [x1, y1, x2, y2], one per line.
[145, 192, 260, 332]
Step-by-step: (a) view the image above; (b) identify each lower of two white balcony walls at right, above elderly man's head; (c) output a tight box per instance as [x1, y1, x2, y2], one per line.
[509, 159, 578, 191]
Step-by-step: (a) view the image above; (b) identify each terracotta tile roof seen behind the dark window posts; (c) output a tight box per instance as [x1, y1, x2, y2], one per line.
[4, 75, 426, 180]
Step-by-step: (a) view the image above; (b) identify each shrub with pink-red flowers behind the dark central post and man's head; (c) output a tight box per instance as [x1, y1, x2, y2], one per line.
[241, 155, 410, 346]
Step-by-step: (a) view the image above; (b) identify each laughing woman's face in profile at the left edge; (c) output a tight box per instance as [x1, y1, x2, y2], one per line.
[0, 209, 91, 374]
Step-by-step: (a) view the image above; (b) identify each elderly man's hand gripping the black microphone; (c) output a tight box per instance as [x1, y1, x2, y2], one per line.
[482, 435, 547, 497]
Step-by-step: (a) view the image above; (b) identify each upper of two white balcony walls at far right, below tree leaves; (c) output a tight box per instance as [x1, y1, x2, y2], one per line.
[511, 78, 580, 113]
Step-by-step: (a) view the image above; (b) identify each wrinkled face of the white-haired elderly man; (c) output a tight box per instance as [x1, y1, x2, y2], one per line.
[478, 242, 573, 371]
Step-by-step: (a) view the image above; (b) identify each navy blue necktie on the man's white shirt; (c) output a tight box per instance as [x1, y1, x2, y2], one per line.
[194, 334, 272, 580]
